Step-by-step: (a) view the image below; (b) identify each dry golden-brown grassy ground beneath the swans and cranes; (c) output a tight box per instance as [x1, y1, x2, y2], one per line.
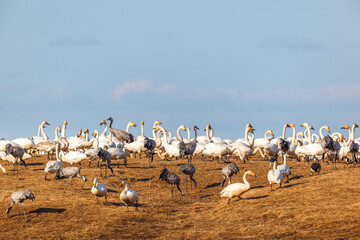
[0, 154, 360, 239]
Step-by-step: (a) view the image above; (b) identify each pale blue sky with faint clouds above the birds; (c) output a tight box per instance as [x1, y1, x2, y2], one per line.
[0, 0, 360, 139]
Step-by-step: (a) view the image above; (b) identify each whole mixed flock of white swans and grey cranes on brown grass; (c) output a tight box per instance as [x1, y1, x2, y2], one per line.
[0, 117, 360, 218]
